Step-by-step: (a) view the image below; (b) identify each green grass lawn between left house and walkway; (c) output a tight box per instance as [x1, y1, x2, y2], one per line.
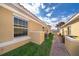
[2, 34, 53, 56]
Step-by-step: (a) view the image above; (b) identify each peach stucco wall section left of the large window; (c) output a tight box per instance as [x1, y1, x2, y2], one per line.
[0, 6, 14, 42]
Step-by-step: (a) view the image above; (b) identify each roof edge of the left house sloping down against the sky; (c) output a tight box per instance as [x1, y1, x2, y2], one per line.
[0, 3, 47, 27]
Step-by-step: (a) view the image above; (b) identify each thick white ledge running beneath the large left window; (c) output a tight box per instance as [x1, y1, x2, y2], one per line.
[0, 36, 31, 48]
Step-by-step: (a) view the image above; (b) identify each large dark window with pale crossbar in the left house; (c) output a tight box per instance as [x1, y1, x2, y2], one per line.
[14, 17, 28, 37]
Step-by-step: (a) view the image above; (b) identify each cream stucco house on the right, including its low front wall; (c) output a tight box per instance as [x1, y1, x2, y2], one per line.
[60, 13, 79, 55]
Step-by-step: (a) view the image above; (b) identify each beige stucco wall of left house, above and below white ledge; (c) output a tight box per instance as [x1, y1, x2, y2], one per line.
[0, 6, 49, 54]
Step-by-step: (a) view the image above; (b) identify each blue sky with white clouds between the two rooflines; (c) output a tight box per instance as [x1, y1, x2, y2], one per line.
[22, 3, 79, 27]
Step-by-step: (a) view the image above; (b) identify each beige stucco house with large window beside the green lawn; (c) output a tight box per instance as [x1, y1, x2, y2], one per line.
[0, 3, 49, 54]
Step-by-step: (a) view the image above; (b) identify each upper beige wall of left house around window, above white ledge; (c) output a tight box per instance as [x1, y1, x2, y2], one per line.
[0, 7, 47, 42]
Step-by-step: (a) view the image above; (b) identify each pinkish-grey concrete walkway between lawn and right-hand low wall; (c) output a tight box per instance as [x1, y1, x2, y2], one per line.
[50, 36, 69, 56]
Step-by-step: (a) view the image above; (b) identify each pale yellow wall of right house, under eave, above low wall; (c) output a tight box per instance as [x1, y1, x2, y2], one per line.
[61, 19, 79, 36]
